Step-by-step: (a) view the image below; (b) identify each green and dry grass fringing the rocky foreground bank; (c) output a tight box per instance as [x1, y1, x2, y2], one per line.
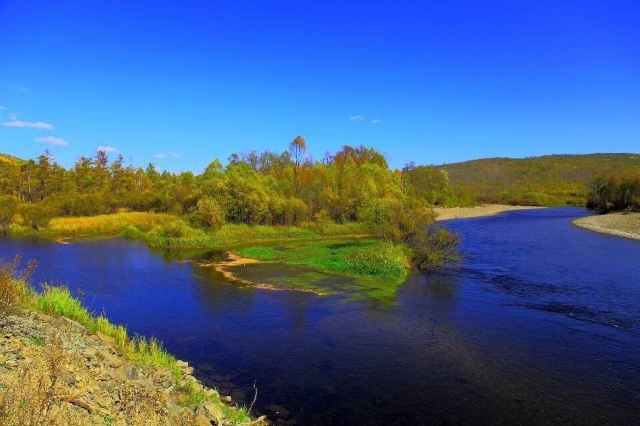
[0, 258, 252, 425]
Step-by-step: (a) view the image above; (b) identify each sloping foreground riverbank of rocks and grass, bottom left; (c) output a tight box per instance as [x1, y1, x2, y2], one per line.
[0, 264, 266, 426]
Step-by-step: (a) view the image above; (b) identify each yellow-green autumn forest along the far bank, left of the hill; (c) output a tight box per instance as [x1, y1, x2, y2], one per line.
[0, 136, 457, 275]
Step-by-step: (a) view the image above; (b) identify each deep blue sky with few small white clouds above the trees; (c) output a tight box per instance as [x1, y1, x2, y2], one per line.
[0, 0, 640, 171]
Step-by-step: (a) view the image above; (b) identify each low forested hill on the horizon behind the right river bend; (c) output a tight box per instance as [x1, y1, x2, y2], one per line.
[438, 154, 640, 205]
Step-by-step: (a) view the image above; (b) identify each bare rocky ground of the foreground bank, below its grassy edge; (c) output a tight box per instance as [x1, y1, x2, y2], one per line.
[0, 312, 267, 426]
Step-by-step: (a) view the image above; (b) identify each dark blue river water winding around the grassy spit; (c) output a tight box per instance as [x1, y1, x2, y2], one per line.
[0, 208, 640, 425]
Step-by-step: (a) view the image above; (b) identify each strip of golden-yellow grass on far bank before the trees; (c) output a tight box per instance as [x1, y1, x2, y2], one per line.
[47, 212, 179, 234]
